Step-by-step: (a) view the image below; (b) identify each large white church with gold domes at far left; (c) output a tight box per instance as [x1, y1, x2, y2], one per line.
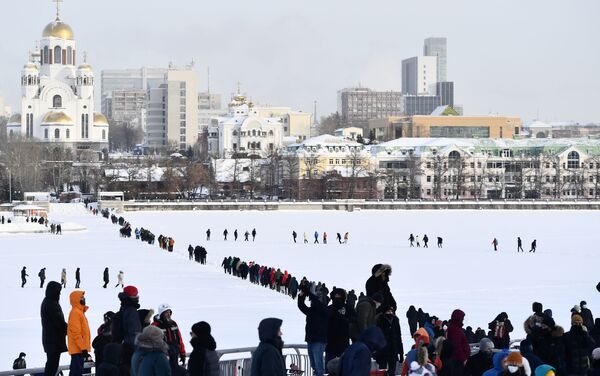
[7, 3, 108, 154]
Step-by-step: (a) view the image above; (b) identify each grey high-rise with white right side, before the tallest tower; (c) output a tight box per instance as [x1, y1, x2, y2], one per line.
[402, 56, 438, 95]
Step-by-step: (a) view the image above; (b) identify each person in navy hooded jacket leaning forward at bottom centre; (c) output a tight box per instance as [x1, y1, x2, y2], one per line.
[337, 326, 386, 376]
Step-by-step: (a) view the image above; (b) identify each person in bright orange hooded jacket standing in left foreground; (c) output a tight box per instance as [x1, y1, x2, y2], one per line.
[67, 290, 92, 376]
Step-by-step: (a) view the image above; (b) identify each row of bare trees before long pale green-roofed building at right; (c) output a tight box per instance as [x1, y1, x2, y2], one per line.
[379, 153, 600, 199]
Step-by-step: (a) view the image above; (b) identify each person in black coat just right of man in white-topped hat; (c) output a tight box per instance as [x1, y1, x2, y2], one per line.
[188, 321, 219, 376]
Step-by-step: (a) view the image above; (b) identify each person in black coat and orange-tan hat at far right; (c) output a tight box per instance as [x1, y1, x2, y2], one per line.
[563, 315, 596, 375]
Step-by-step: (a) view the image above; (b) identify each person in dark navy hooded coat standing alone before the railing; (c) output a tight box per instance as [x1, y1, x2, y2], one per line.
[250, 318, 286, 376]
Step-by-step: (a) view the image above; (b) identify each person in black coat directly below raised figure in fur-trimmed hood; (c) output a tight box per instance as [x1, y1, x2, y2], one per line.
[376, 307, 404, 376]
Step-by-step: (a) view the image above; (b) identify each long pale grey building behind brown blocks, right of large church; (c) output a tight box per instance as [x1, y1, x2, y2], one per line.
[100, 67, 167, 115]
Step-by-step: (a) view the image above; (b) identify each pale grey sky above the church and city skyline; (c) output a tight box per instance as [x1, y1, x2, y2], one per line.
[0, 0, 600, 122]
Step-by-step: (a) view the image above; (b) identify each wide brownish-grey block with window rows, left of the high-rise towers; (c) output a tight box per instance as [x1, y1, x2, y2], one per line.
[338, 87, 402, 131]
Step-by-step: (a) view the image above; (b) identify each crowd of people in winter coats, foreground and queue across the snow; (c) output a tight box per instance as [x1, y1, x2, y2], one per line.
[18, 207, 600, 376]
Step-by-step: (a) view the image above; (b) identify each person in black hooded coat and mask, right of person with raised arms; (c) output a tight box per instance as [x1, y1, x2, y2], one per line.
[325, 288, 353, 364]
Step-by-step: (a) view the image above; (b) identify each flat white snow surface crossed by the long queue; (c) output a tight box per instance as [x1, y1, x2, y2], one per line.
[0, 204, 600, 369]
